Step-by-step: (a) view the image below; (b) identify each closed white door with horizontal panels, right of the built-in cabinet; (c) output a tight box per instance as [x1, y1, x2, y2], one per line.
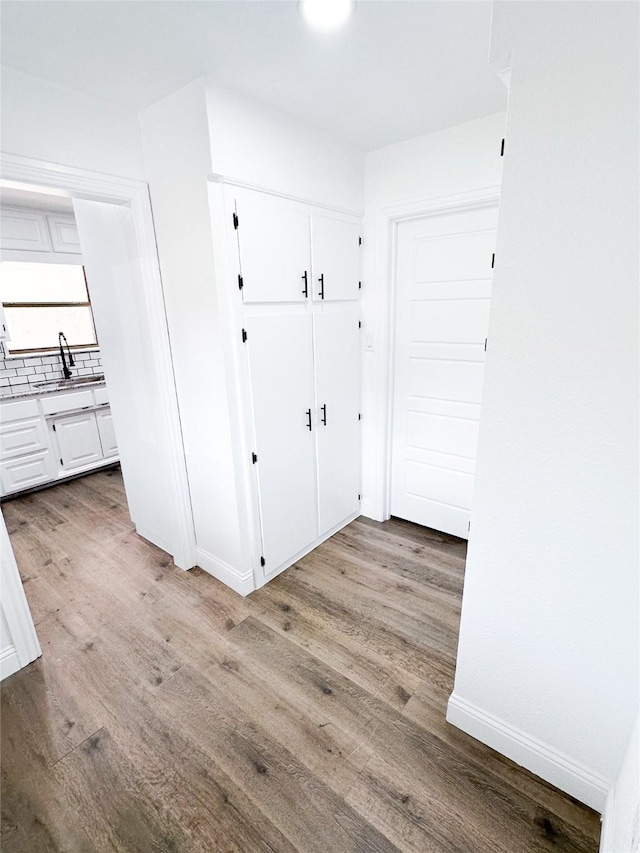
[391, 207, 497, 538]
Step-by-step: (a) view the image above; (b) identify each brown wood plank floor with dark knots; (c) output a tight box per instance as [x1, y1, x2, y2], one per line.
[2, 470, 600, 853]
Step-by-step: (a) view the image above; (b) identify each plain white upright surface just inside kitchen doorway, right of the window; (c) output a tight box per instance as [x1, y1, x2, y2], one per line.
[73, 199, 181, 558]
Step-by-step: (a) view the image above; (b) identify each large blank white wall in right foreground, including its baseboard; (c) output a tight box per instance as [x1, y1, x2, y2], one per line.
[450, 2, 639, 808]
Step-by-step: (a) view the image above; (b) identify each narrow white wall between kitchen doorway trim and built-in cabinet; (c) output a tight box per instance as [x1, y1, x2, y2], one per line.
[140, 79, 242, 584]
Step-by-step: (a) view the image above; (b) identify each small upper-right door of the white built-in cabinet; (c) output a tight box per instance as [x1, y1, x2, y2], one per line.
[311, 214, 362, 301]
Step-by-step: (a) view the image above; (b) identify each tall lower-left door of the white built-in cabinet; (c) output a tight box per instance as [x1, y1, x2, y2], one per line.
[246, 313, 317, 576]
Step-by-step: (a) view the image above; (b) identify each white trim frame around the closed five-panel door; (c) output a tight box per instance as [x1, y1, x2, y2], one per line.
[370, 184, 500, 521]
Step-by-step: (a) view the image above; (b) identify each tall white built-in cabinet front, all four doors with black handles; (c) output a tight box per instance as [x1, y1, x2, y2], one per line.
[226, 187, 362, 586]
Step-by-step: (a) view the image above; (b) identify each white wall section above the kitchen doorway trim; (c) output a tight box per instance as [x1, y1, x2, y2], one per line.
[0, 67, 144, 178]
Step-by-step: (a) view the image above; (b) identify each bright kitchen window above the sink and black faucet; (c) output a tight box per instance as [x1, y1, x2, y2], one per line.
[0, 261, 98, 355]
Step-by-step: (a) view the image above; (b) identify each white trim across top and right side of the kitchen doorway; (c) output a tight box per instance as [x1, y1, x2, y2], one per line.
[0, 153, 196, 569]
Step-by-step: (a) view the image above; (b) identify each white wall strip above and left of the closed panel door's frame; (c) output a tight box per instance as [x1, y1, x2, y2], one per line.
[362, 113, 505, 521]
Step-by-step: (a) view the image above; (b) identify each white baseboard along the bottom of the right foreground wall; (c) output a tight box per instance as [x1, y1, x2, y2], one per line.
[447, 693, 611, 814]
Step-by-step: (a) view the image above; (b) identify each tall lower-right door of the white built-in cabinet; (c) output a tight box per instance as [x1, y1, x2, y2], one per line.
[313, 305, 360, 536]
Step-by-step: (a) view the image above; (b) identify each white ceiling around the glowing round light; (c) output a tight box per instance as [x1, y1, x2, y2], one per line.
[0, 0, 506, 150]
